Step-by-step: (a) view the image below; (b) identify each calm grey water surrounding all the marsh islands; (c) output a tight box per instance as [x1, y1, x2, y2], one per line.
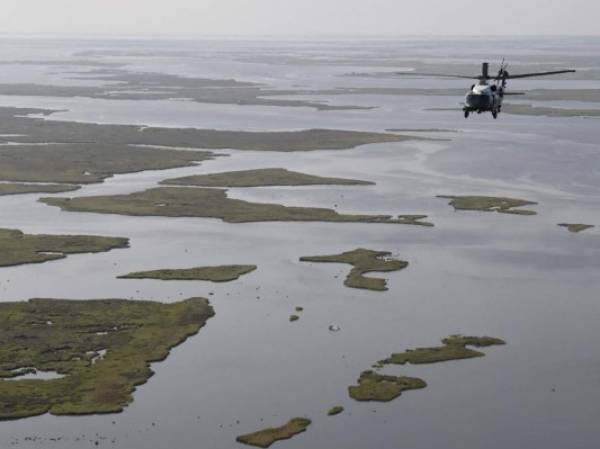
[0, 40, 600, 449]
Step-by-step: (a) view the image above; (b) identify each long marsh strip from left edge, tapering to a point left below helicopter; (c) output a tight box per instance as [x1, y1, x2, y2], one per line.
[0, 107, 412, 153]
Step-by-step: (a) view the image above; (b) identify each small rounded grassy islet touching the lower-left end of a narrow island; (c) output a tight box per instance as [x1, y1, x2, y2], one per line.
[348, 371, 427, 402]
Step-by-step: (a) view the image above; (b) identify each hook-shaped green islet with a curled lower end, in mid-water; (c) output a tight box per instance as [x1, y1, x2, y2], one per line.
[300, 248, 408, 291]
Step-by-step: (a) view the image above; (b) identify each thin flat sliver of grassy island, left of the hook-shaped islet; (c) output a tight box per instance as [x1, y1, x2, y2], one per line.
[118, 265, 256, 282]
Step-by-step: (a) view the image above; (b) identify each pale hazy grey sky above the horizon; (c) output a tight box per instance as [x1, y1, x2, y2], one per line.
[0, 0, 600, 35]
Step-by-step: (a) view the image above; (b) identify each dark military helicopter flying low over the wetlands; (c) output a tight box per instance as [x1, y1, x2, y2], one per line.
[396, 60, 575, 119]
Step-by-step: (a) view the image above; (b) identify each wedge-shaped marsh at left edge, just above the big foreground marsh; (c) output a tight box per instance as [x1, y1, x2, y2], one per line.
[0, 229, 129, 267]
